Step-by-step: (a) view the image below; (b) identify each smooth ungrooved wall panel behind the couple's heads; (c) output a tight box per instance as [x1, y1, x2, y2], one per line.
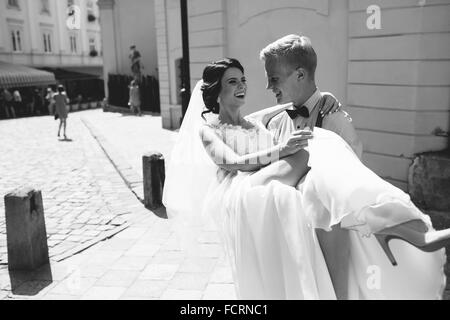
[224, 0, 348, 114]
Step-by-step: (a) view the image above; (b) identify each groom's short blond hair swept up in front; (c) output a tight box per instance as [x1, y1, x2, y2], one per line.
[259, 34, 317, 79]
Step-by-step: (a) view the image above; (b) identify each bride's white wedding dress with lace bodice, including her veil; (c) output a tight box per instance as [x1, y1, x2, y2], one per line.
[163, 85, 446, 300]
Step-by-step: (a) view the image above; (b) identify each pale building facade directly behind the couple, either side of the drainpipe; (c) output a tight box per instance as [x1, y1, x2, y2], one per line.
[155, 0, 450, 190]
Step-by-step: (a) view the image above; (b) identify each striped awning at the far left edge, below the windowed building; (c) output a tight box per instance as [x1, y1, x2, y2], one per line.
[0, 61, 56, 88]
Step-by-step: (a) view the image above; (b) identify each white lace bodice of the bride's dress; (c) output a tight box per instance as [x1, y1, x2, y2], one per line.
[209, 122, 274, 155]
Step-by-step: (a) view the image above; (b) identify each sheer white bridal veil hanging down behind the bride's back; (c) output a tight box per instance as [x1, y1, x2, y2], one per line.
[163, 81, 217, 254]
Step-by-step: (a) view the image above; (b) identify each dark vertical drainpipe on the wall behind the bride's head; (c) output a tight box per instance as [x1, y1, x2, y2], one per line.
[180, 0, 191, 118]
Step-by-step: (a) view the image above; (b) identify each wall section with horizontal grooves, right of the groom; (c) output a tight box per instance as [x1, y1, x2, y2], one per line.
[347, 0, 450, 190]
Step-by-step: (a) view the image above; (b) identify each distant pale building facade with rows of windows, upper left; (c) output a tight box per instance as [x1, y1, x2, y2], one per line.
[0, 0, 103, 74]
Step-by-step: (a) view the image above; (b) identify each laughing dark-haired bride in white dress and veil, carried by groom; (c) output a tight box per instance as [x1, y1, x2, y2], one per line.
[163, 59, 450, 299]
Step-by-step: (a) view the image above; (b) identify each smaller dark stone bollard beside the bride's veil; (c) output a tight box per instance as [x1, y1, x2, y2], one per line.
[142, 152, 166, 209]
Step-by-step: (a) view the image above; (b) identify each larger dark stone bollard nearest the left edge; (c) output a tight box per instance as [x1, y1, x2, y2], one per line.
[5, 188, 49, 271]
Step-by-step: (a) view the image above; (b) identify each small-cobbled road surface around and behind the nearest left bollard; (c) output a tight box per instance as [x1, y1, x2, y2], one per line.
[0, 113, 143, 264]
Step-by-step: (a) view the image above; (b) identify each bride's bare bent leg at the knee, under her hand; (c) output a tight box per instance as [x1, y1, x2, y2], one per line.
[250, 150, 309, 187]
